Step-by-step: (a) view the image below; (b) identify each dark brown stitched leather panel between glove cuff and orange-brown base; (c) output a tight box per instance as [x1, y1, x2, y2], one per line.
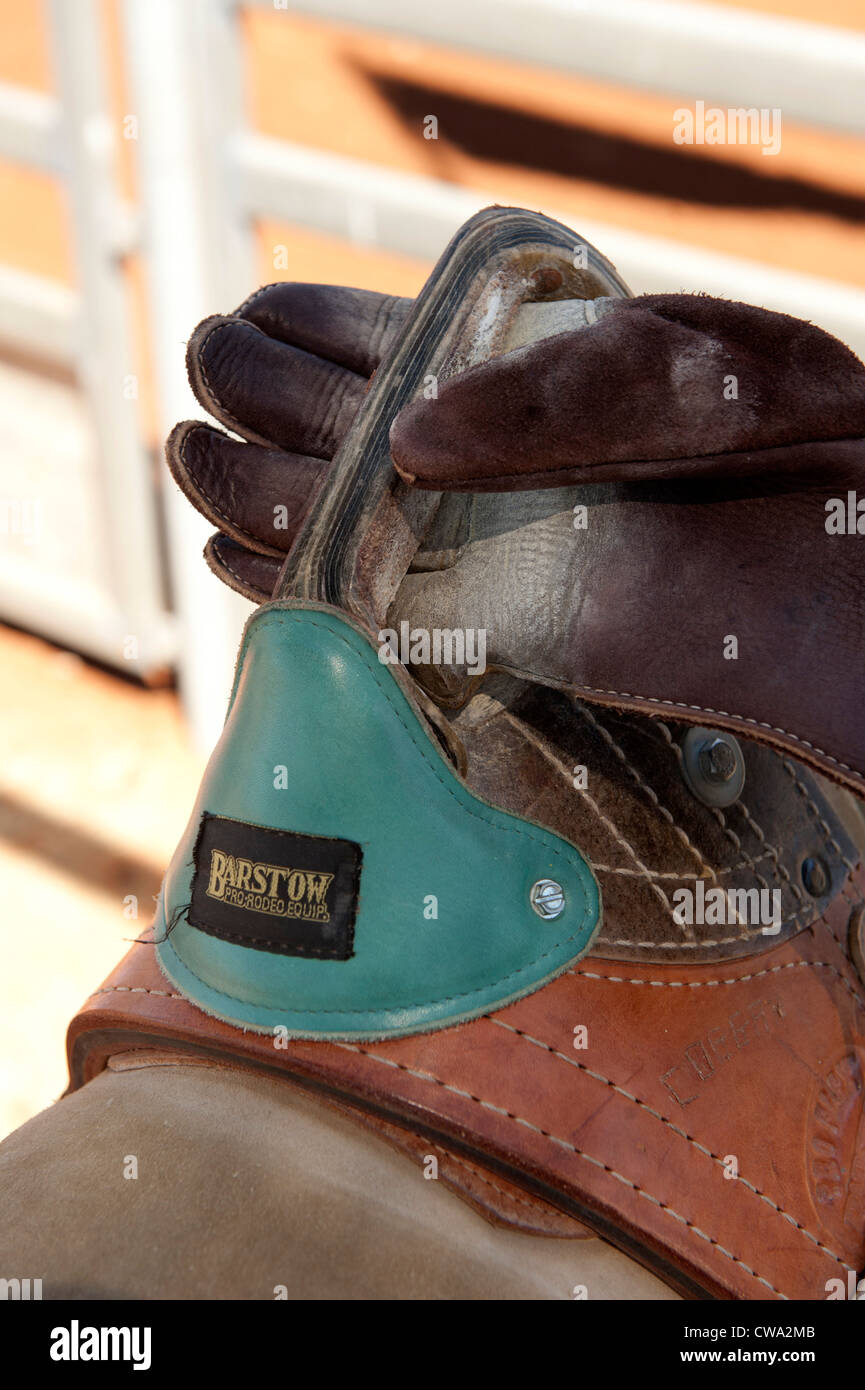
[453, 681, 865, 963]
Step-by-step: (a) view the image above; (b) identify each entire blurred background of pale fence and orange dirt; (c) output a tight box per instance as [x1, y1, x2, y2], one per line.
[0, 0, 865, 1136]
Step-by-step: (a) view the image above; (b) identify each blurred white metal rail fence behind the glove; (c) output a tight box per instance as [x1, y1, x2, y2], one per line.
[0, 0, 865, 744]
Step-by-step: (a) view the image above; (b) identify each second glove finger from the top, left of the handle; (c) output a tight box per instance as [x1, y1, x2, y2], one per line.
[186, 314, 367, 459]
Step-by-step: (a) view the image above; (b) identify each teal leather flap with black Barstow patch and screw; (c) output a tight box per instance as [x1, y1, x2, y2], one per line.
[156, 602, 601, 1040]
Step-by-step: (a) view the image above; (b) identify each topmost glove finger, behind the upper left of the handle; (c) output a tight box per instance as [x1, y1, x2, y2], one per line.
[234, 282, 413, 377]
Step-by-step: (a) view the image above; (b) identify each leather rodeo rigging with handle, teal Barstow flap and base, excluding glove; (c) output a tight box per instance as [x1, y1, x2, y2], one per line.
[68, 210, 865, 1300]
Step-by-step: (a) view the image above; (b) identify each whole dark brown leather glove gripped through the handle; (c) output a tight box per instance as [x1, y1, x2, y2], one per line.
[168, 285, 865, 794]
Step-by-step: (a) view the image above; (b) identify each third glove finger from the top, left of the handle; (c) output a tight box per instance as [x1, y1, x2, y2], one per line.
[165, 420, 330, 557]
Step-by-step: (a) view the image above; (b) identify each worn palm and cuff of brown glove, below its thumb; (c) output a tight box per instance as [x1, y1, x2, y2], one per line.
[387, 453, 865, 795]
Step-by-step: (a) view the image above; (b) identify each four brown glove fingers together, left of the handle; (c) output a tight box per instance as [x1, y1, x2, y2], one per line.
[165, 284, 412, 603]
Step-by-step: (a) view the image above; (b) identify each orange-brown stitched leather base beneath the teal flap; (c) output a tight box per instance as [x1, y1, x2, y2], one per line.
[68, 870, 865, 1298]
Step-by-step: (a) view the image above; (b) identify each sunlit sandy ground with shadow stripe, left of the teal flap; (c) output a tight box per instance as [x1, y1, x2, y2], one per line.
[0, 631, 203, 1137]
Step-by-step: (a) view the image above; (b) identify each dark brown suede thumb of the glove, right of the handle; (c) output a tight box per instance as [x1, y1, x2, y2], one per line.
[391, 295, 865, 492]
